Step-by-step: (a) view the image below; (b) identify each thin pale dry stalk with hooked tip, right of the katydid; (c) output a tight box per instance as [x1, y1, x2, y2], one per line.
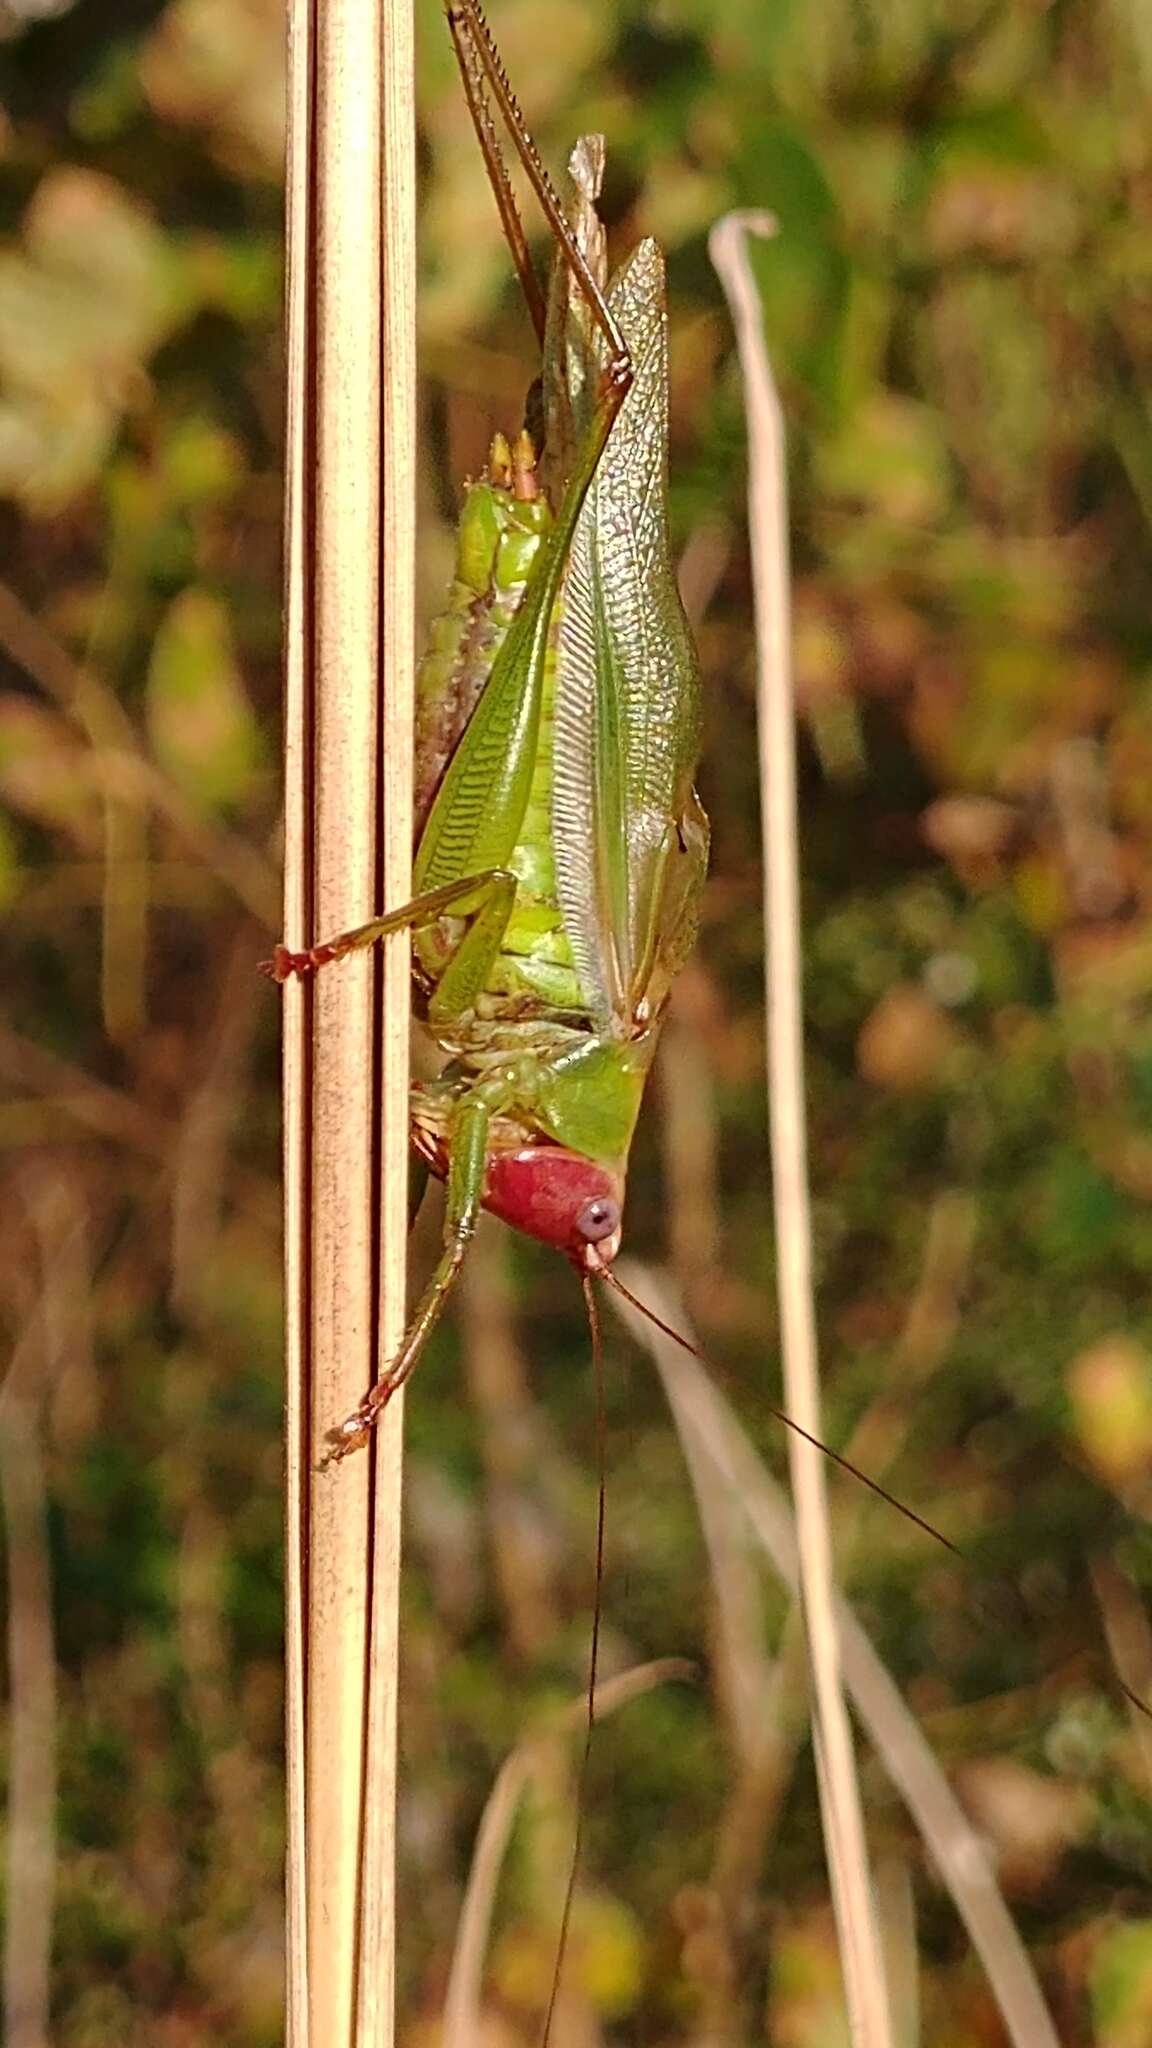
[709, 213, 892, 2048]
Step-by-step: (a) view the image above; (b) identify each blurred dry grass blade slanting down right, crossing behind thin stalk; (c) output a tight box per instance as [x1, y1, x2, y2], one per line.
[613, 1262, 1060, 2048]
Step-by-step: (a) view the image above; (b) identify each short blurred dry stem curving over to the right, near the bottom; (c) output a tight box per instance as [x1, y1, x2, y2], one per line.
[443, 1657, 697, 2048]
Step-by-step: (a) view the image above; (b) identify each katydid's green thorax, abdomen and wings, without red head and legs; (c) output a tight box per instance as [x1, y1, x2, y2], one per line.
[414, 137, 707, 1235]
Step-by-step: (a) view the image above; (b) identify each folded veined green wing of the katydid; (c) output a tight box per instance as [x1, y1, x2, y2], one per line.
[545, 137, 707, 1036]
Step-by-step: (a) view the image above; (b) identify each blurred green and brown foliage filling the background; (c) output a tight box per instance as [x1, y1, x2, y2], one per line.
[0, 0, 1152, 2048]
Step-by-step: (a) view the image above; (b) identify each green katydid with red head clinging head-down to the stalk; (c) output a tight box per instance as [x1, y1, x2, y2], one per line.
[266, 0, 707, 1456]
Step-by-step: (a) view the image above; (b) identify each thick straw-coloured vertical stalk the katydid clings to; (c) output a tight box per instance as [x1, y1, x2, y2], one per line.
[285, 0, 414, 2048]
